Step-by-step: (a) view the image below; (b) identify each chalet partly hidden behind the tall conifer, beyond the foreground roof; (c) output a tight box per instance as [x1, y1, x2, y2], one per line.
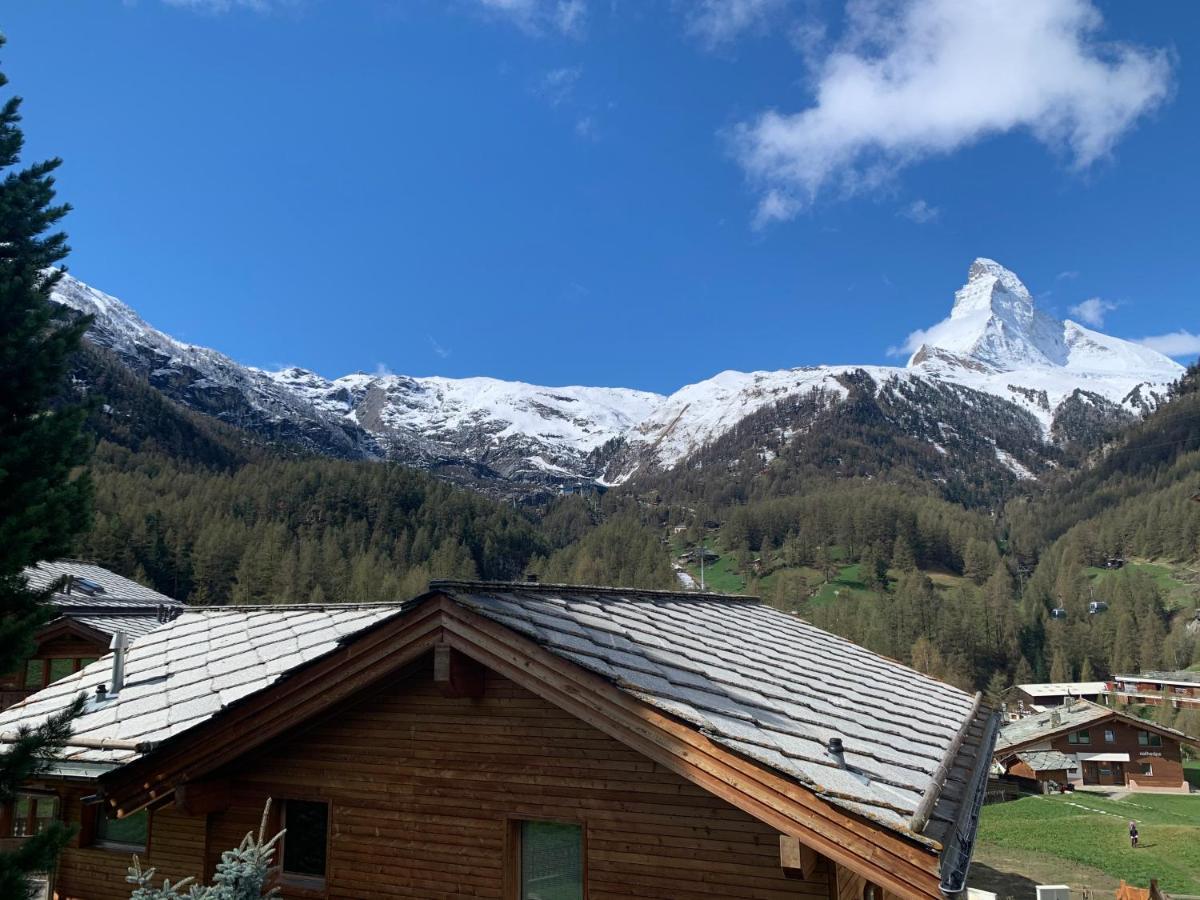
[0, 559, 184, 709]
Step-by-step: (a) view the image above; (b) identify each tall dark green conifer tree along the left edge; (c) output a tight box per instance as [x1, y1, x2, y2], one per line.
[0, 36, 90, 898]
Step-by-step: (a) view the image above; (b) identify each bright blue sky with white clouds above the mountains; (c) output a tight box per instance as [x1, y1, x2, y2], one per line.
[0, 0, 1200, 391]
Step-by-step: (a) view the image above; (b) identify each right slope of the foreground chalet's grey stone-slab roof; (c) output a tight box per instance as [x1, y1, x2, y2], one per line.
[431, 582, 991, 859]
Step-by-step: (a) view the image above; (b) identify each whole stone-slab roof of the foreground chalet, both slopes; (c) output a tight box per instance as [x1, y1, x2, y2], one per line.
[0, 582, 995, 883]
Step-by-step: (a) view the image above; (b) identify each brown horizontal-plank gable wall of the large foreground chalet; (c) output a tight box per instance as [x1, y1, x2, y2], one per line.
[208, 658, 830, 900]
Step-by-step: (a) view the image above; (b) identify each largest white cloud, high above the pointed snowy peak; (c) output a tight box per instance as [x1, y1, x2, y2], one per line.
[733, 0, 1171, 223]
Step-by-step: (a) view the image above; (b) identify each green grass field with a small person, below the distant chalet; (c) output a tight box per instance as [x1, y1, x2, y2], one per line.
[979, 796, 1200, 894]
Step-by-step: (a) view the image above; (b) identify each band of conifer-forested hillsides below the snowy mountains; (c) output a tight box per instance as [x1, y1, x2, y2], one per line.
[65, 349, 1200, 710]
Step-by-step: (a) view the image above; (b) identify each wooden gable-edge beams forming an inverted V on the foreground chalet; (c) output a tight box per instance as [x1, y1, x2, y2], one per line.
[93, 595, 941, 898]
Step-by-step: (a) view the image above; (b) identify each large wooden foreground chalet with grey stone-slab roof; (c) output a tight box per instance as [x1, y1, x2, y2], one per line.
[0, 582, 997, 900]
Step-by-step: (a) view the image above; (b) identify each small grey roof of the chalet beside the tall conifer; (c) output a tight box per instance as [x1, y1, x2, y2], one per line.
[24, 559, 185, 637]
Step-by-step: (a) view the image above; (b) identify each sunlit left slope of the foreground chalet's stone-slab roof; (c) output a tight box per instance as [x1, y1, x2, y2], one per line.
[0, 604, 403, 768]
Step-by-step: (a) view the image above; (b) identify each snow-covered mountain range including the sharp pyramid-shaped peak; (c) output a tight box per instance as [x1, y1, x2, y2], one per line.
[55, 259, 1183, 501]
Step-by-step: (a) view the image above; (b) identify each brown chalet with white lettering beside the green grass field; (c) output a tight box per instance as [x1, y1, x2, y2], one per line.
[996, 700, 1200, 792]
